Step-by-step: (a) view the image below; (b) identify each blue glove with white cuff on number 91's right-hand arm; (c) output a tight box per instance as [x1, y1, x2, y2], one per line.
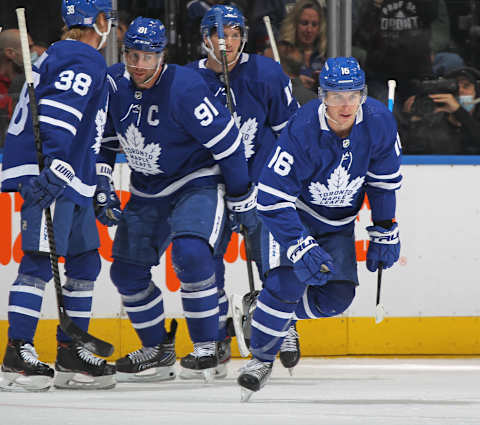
[225, 185, 258, 233]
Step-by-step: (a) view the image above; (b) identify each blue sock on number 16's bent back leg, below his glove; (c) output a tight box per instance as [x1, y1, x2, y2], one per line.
[295, 281, 356, 319]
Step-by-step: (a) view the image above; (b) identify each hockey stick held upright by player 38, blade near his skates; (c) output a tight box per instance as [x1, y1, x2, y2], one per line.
[16, 8, 113, 357]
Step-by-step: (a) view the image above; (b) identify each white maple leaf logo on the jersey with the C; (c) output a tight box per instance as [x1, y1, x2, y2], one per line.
[118, 124, 163, 175]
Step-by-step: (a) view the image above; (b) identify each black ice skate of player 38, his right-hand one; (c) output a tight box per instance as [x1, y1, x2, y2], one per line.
[54, 342, 116, 390]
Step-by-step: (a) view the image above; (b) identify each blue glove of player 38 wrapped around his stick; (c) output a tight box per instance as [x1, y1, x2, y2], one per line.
[21, 158, 75, 209]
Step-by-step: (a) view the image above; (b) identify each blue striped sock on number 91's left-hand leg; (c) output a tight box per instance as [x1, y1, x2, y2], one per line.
[110, 260, 167, 347]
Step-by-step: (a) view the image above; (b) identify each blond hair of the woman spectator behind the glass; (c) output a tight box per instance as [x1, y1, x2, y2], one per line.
[280, 0, 327, 57]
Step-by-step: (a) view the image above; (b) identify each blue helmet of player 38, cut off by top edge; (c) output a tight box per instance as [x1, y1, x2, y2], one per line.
[62, 0, 113, 28]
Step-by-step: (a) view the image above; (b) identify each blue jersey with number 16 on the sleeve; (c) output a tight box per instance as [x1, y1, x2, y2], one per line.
[257, 98, 402, 248]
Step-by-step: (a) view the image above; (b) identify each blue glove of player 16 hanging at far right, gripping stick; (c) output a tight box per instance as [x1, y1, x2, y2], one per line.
[367, 223, 400, 272]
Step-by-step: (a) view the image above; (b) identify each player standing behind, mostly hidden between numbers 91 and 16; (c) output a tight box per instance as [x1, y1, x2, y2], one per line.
[184, 5, 299, 379]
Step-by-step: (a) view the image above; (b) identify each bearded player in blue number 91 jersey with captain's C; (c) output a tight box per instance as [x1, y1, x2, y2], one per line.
[101, 17, 256, 381]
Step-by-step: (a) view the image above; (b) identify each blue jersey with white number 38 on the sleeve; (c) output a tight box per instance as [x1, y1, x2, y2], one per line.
[2, 40, 108, 205]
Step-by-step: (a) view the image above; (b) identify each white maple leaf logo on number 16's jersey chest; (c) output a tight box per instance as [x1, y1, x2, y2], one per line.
[308, 163, 365, 207]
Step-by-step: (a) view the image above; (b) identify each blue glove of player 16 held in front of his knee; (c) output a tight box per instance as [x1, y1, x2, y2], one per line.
[287, 236, 335, 286]
